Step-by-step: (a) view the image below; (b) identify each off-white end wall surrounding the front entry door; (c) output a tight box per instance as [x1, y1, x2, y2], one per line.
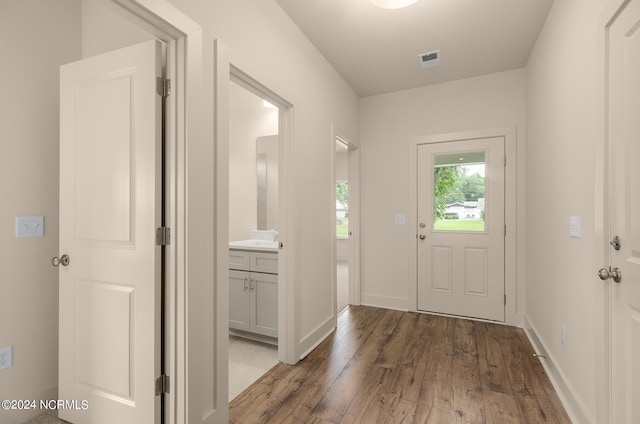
[360, 69, 525, 310]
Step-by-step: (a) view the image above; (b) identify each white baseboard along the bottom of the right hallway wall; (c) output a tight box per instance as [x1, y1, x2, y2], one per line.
[524, 315, 595, 424]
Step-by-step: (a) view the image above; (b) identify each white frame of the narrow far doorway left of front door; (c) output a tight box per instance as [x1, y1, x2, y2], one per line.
[329, 132, 361, 318]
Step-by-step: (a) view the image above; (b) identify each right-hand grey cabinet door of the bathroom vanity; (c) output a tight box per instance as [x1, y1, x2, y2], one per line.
[250, 272, 278, 337]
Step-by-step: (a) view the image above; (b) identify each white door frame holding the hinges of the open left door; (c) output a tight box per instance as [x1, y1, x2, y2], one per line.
[94, 0, 203, 424]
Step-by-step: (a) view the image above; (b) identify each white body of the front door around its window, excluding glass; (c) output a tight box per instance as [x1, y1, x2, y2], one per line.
[416, 137, 505, 322]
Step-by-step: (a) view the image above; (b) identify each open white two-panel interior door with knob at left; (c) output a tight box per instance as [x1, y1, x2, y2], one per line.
[58, 41, 161, 424]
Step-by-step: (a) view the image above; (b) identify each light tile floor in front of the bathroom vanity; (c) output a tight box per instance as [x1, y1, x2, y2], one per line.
[229, 335, 278, 401]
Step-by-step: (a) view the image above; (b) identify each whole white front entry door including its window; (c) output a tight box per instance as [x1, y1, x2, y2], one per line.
[416, 137, 505, 321]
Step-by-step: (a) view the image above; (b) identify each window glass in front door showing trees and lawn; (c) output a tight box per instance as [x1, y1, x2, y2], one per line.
[433, 152, 486, 231]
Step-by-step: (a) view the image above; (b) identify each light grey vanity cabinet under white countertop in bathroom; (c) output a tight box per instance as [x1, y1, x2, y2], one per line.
[229, 249, 278, 339]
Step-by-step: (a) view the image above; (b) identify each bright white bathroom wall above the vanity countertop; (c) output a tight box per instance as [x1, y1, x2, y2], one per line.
[229, 84, 278, 241]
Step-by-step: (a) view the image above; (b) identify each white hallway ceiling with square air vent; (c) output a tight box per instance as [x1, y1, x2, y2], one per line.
[276, 0, 553, 97]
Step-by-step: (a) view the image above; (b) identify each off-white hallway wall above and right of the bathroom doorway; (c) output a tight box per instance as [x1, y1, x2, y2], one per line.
[165, 0, 358, 362]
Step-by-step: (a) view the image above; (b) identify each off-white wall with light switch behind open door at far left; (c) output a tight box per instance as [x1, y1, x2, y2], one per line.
[0, 0, 80, 424]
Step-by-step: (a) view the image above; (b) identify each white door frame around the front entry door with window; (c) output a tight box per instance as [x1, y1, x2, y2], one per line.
[407, 127, 524, 326]
